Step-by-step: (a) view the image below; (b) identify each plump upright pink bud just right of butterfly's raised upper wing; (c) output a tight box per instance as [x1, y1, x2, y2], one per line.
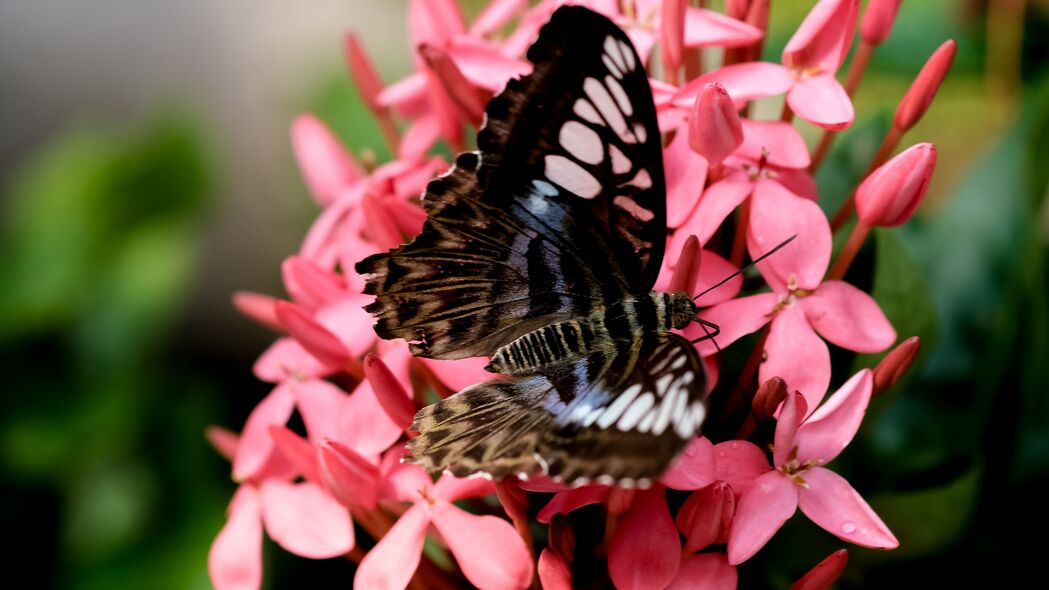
[688, 83, 743, 166]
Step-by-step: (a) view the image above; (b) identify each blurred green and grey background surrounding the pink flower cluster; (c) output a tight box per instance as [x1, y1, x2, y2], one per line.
[0, 0, 1049, 589]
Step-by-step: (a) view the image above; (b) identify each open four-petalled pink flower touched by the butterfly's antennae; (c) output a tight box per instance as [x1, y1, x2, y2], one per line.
[686, 181, 896, 410]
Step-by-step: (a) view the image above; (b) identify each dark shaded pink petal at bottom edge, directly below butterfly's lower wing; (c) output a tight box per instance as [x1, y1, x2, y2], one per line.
[608, 488, 681, 590]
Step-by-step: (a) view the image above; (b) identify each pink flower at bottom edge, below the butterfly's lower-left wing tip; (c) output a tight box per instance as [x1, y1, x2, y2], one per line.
[354, 451, 532, 590]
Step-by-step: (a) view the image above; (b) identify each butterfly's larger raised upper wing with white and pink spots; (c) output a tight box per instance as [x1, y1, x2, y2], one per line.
[357, 6, 666, 359]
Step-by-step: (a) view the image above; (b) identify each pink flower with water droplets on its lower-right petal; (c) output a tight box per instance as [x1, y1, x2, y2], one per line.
[728, 370, 899, 564]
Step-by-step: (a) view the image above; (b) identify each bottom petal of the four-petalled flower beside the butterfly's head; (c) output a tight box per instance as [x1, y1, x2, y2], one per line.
[757, 308, 831, 414]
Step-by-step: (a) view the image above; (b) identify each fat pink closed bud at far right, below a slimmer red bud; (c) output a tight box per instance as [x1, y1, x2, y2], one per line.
[856, 144, 936, 228]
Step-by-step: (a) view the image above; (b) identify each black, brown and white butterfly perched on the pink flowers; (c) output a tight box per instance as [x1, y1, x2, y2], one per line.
[357, 6, 707, 486]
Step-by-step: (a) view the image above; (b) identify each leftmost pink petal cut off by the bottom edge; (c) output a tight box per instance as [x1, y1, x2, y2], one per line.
[208, 485, 262, 590]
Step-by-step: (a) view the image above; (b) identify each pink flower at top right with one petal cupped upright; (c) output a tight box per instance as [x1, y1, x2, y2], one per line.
[673, 0, 859, 130]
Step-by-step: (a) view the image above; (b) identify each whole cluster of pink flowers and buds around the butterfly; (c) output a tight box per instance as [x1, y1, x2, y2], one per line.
[209, 0, 954, 590]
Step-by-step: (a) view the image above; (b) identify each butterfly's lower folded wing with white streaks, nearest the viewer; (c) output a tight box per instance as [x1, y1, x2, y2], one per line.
[409, 333, 706, 485]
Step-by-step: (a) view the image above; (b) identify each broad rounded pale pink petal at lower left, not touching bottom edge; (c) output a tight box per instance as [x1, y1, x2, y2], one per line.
[259, 480, 354, 560]
